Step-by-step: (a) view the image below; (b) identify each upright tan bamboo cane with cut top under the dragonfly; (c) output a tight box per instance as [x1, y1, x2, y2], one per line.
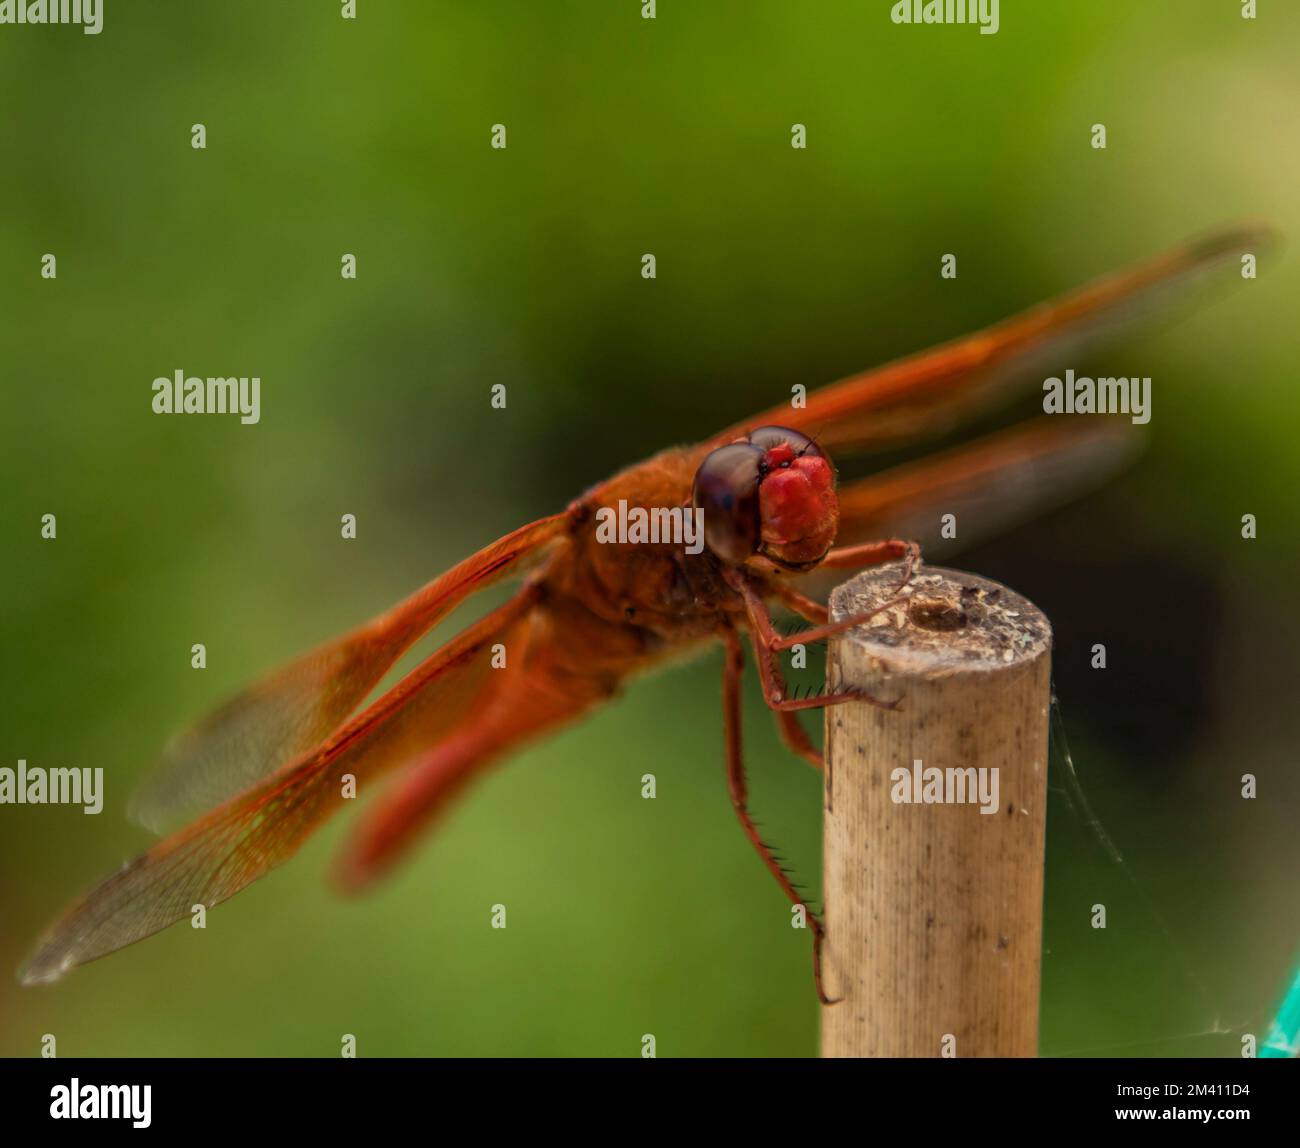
[822, 564, 1052, 1057]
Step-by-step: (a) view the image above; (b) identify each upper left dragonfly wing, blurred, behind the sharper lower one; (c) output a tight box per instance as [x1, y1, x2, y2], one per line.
[130, 514, 569, 832]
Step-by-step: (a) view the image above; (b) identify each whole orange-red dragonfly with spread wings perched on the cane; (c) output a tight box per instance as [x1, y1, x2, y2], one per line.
[20, 228, 1268, 1000]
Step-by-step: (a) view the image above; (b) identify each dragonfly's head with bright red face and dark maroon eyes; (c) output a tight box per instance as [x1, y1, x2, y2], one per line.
[693, 426, 840, 569]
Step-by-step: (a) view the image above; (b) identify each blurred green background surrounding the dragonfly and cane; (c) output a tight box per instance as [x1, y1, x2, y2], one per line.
[0, 0, 1300, 1056]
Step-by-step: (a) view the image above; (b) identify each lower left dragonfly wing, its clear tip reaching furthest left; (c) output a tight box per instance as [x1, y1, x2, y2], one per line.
[18, 586, 536, 984]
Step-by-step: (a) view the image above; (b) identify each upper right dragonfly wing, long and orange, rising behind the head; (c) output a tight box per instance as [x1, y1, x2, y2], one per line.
[709, 228, 1273, 454]
